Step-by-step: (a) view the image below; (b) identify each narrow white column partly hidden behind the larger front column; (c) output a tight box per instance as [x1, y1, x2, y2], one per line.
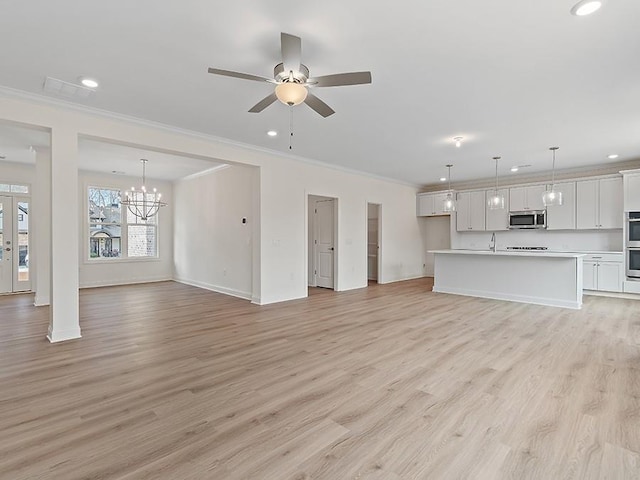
[30, 144, 51, 307]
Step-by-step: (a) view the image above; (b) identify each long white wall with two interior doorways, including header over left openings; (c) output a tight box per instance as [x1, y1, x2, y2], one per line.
[0, 90, 424, 312]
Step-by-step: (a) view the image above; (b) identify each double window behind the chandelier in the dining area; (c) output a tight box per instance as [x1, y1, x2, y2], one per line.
[88, 187, 158, 258]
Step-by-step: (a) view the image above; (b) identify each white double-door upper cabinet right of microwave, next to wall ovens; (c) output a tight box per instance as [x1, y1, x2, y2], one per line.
[576, 177, 623, 230]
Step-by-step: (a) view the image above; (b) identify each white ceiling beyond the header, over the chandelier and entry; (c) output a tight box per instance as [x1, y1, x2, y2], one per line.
[0, 123, 222, 181]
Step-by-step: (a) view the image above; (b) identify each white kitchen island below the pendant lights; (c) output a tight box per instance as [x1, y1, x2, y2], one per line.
[430, 250, 584, 309]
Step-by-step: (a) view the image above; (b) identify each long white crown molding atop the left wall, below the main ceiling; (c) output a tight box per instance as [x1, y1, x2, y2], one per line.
[0, 85, 421, 189]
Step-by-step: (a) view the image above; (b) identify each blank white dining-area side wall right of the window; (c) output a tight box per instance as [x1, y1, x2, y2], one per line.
[174, 165, 259, 299]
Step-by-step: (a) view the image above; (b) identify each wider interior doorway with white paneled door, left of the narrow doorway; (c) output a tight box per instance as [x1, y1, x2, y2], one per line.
[308, 195, 338, 290]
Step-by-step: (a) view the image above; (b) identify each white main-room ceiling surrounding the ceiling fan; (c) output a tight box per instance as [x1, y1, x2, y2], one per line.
[0, 0, 640, 184]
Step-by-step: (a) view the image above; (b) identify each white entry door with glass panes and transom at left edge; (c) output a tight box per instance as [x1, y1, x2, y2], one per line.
[0, 193, 31, 294]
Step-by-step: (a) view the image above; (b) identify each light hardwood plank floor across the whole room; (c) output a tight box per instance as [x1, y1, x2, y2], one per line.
[0, 279, 640, 480]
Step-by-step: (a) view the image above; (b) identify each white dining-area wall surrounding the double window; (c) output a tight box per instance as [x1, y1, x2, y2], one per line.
[78, 171, 173, 287]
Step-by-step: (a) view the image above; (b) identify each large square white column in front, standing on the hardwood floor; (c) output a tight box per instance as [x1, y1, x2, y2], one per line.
[47, 128, 81, 342]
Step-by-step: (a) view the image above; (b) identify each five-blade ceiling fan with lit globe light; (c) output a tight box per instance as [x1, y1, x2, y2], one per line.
[209, 33, 371, 117]
